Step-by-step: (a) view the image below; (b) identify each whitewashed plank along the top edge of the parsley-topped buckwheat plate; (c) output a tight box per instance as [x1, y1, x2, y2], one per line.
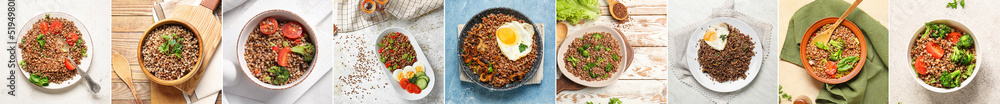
[566, 15, 669, 46]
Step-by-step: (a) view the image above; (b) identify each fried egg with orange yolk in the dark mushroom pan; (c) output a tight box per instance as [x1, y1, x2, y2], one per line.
[495, 21, 535, 61]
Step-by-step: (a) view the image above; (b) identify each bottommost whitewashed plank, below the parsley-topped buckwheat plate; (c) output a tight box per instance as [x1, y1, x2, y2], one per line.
[556, 80, 667, 104]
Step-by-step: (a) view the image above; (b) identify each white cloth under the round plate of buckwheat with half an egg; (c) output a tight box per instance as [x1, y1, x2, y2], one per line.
[669, 0, 777, 103]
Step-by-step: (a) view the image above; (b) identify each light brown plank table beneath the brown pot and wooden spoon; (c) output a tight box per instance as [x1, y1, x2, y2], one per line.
[111, 0, 222, 104]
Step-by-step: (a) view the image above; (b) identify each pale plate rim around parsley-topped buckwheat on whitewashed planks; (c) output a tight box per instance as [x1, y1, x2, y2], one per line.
[556, 26, 632, 87]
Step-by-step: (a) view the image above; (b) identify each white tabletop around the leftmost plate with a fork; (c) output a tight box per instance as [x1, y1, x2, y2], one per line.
[0, 0, 111, 104]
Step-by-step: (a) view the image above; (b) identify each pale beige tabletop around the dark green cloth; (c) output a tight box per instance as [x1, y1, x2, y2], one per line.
[778, 0, 892, 103]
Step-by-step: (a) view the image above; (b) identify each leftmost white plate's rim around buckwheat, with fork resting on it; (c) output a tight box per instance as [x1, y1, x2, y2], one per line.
[14, 12, 94, 89]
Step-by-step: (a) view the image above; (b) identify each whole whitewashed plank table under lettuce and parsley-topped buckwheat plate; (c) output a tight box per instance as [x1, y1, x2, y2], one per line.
[556, 0, 668, 104]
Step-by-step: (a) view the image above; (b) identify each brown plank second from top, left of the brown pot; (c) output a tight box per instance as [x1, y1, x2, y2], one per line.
[111, 15, 153, 32]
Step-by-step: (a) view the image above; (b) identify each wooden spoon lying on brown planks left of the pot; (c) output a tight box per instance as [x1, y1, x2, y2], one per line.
[111, 54, 142, 104]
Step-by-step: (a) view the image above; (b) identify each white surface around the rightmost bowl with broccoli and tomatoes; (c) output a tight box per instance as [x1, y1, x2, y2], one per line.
[888, 0, 1000, 104]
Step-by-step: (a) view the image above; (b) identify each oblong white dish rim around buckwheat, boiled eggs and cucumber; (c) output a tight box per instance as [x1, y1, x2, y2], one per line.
[369, 28, 437, 100]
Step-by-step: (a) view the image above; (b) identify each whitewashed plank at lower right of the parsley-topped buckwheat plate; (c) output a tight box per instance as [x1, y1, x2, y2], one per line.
[618, 47, 669, 80]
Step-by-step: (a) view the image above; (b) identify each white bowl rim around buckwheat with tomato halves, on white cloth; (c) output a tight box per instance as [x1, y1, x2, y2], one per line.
[236, 10, 323, 90]
